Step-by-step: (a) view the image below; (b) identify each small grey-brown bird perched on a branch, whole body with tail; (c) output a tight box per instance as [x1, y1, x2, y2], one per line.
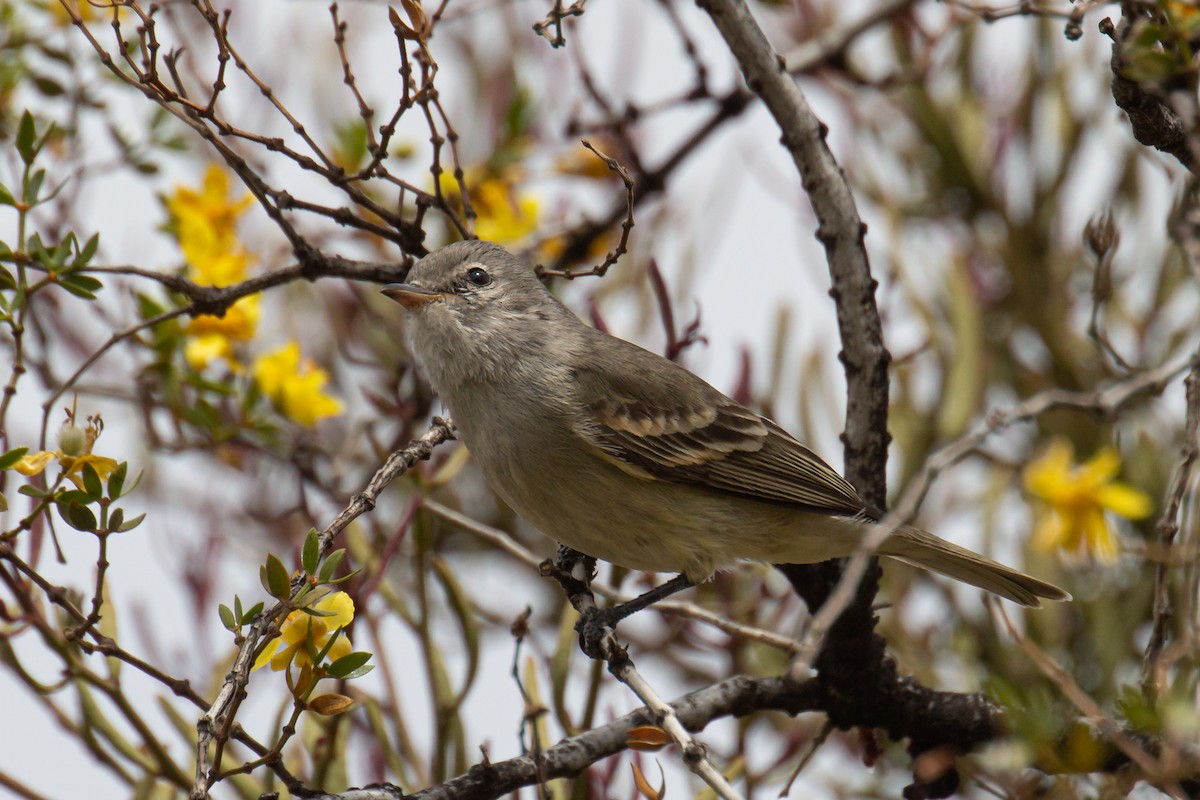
[383, 241, 1070, 606]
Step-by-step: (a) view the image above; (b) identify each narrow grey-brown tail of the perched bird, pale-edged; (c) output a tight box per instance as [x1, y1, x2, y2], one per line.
[878, 527, 1070, 608]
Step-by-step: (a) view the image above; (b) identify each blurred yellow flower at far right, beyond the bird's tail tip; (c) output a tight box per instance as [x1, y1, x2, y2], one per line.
[1024, 439, 1152, 561]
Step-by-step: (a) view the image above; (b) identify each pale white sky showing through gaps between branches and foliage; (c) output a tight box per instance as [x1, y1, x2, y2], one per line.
[0, 0, 1171, 800]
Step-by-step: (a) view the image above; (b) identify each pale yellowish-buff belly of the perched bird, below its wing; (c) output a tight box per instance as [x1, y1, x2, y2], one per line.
[460, 395, 864, 582]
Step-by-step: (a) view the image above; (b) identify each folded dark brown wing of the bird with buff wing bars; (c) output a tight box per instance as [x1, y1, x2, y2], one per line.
[575, 339, 865, 516]
